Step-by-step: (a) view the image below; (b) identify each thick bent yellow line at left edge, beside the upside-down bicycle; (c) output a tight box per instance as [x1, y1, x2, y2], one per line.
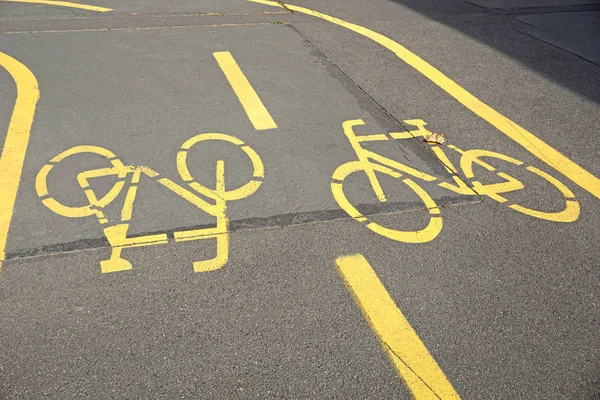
[0, 52, 40, 269]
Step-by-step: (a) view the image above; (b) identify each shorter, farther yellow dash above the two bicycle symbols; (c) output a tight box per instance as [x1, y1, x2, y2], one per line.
[213, 51, 277, 131]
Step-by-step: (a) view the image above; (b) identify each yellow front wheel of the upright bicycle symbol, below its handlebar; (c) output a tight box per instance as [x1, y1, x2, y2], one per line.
[331, 161, 442, 243]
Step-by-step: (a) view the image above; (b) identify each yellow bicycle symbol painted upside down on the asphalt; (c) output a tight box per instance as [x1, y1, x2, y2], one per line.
[36, 133, 264, 273]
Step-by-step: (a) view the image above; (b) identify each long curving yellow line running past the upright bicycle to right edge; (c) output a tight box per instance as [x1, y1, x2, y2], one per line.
[249, 0, 600, 199]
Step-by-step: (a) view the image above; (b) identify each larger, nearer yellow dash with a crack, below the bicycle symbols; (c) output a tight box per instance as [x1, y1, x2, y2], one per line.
[336, 254, 460, 400]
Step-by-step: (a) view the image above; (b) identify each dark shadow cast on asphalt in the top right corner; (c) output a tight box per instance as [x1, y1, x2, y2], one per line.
[390, 0, 600, 103]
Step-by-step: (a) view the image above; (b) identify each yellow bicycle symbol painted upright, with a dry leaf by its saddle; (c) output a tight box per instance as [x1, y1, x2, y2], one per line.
[331, 119, 580, 243]
